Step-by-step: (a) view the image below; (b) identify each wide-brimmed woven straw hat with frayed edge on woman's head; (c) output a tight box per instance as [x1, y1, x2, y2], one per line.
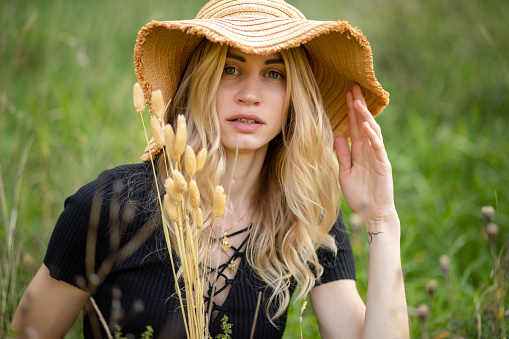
[134, 0, 389, 161]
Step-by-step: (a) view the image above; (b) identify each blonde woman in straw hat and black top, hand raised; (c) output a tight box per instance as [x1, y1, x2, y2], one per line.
[13, 0, 408, 338]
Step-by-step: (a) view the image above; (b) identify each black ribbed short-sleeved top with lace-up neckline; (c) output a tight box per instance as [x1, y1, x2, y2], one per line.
[44, 163, 355, 338]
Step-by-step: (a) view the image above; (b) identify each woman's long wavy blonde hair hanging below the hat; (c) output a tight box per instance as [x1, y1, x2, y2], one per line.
[158, 40, 339, 320]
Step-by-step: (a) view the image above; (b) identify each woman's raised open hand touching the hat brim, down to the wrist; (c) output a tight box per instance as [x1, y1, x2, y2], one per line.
[334, 84, 397, 231]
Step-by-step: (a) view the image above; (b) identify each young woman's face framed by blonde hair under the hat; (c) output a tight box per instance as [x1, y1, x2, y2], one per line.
[216, 48, 286, 152]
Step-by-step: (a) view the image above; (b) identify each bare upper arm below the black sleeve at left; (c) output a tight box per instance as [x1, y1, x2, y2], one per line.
[12, 264, 90, 338]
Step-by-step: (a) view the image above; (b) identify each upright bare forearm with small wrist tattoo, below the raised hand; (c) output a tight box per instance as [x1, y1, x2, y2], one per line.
[363, 213, 409, 339]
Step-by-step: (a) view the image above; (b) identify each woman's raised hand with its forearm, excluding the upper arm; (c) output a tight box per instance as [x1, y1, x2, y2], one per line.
[325, 84, 409, 339]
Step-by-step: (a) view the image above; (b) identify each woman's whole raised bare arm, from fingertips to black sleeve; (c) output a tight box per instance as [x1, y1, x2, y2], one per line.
[311, 84, 409, 338]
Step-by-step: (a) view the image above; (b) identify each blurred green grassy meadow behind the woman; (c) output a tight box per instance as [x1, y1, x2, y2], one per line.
[0, 0, 509, 338]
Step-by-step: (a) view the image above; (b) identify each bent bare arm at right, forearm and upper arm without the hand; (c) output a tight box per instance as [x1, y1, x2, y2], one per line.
[310, 216, 409, 339]
